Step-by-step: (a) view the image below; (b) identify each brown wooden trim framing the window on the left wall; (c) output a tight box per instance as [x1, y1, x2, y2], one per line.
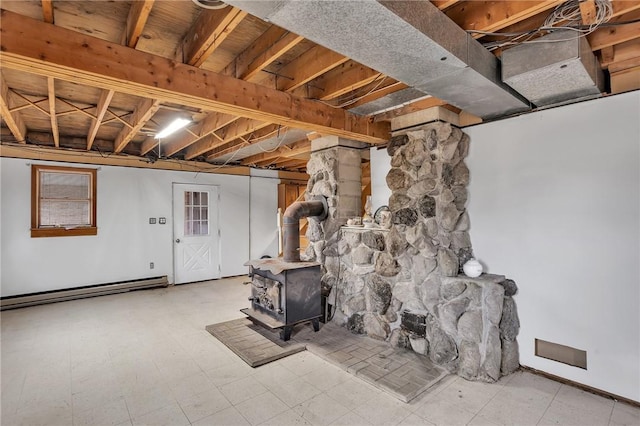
[31, 164, 98, 238]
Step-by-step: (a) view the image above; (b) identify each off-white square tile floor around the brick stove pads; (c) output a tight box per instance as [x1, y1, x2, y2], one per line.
[0, 277, 640, 426]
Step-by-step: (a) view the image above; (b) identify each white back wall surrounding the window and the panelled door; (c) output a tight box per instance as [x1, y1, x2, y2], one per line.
[0, 158, 277, 297]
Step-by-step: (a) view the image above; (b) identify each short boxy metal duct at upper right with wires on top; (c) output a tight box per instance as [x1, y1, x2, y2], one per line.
[502, 30, 604, 107]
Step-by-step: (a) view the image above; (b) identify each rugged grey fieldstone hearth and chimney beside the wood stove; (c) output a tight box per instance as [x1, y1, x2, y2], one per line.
[307, 123, 519, 381]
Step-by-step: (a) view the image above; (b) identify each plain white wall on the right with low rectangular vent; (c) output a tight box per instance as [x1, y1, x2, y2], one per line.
[465, 91, 640, 401]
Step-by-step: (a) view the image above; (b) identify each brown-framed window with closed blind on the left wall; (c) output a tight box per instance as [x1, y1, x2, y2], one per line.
[31, 165, 98, 237]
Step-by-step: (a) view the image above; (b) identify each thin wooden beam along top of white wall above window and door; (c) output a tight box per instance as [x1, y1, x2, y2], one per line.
[0, 144, 251, 176]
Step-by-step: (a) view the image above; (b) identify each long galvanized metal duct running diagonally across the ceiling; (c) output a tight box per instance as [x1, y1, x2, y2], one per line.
[227, 0, 529, 119]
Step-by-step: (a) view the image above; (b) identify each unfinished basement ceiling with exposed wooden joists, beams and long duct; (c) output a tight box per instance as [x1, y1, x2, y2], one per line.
[0, 0, 640, 171]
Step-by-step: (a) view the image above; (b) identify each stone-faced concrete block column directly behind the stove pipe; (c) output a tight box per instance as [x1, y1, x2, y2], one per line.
[305, 136, 366, 290]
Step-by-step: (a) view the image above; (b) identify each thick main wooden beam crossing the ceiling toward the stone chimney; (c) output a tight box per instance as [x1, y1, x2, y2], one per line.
[0, 10, 389, 143]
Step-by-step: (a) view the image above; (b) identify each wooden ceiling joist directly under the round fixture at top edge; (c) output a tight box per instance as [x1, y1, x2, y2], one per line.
[181, 6, 247, 67]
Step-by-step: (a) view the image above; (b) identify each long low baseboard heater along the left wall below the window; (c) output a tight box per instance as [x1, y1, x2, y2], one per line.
[0, 275, 169, 311]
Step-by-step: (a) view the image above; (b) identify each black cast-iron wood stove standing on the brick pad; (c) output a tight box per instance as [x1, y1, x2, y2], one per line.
[241, 258, 322, 341]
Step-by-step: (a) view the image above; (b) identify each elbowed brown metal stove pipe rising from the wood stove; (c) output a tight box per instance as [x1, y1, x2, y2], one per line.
[282, 196, 328, 262]
